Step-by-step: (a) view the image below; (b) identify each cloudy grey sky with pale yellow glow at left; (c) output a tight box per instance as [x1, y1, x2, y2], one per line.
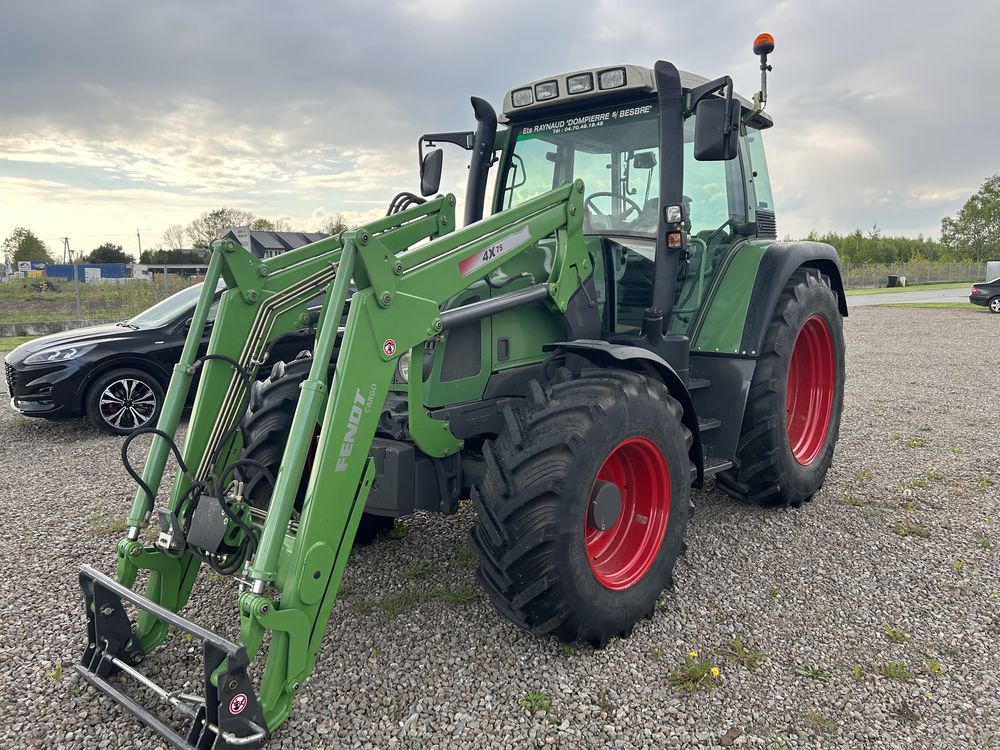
[0, 0, 1000, 252]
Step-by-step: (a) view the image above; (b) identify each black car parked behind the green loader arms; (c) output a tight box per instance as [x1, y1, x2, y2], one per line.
[4, 284, 316, 435]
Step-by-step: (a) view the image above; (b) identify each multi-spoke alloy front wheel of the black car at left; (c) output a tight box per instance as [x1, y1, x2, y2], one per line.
[86, 369, 163, 435]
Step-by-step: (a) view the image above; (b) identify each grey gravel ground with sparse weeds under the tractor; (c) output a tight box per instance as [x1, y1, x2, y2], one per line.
[0, 308, 1000, 750]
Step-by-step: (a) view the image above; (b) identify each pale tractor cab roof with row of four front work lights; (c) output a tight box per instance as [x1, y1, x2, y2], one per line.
[503, 65, 774, 130]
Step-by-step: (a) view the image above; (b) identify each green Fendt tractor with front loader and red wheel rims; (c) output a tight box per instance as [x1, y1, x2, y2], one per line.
[77, 35, 847, 749]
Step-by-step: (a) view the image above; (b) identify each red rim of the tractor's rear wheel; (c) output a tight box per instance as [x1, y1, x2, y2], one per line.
[785, 315, 836, 466]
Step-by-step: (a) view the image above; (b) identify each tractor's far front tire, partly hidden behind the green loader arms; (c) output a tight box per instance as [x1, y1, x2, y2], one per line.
[239, 352, 395, 544]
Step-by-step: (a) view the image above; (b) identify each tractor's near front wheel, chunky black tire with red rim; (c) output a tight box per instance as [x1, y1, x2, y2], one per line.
[471, 368, 692, 647]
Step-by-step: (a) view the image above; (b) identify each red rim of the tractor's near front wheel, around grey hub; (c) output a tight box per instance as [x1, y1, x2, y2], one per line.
[584, 437, 670, 591]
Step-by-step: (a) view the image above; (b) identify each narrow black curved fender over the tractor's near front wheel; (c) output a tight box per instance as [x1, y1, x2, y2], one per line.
[542, 339, 705, 487]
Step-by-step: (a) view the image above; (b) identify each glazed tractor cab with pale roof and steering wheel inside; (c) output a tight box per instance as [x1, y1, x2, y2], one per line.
[493, 65, 775, 338]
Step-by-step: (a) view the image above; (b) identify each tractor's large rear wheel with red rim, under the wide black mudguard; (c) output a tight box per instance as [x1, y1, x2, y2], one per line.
[717, 268, 844, 506]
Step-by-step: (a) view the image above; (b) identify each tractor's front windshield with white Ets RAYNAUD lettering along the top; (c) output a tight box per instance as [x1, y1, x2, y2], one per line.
[503, 103, 659, 235]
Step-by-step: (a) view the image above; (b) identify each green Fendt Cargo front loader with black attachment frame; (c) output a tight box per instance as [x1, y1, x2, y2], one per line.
[84, 180, 599, 749]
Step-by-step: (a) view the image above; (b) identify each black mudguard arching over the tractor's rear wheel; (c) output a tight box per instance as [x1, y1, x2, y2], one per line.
[740, 241, 847, 356]
